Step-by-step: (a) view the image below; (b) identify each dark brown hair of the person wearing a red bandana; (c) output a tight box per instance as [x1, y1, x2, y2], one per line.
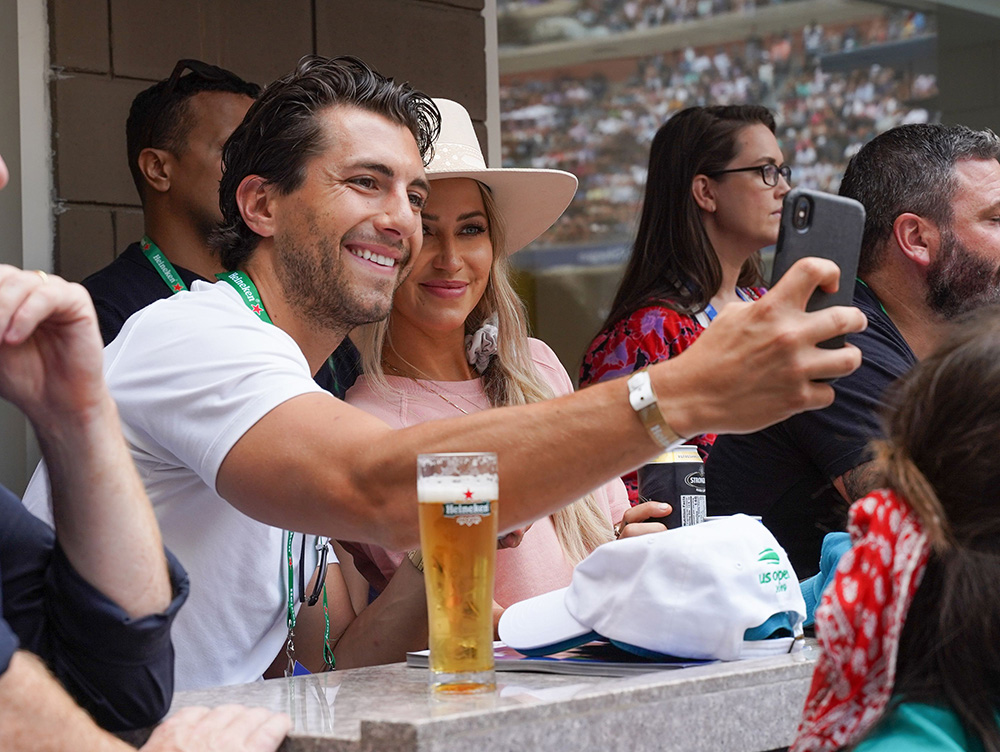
[876, 307, 1000, 752]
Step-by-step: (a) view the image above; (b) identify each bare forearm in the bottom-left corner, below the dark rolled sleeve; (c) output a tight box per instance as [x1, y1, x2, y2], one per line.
[0, 651, 134, 752]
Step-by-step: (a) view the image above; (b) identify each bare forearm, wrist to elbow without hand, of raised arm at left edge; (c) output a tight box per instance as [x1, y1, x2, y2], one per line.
[38, 392, 172, 618]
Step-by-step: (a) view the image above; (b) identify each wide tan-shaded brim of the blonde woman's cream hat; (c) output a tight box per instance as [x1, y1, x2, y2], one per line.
[427, 167, 577, 253]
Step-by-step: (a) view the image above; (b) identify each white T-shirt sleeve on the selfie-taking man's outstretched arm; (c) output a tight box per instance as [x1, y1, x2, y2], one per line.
[105, 282, 326, 488]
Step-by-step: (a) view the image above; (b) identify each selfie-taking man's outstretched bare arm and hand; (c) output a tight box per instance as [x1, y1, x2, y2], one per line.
[217, 259, 866, 550]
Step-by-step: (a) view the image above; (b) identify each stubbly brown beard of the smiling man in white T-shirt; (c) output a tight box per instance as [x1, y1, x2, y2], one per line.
[275, 223, 408, 334]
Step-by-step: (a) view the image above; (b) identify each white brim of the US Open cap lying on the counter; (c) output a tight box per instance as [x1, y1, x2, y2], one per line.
[497, 588, 597, 655]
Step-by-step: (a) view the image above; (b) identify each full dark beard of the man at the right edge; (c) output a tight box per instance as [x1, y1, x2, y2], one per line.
[927, 229, 1000, 319]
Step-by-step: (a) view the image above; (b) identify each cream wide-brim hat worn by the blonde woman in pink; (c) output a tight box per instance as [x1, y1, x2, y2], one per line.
[427, 99, 577, 253]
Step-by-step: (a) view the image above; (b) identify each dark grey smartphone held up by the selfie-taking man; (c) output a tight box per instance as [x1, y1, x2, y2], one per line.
[771, 188, 865, 349]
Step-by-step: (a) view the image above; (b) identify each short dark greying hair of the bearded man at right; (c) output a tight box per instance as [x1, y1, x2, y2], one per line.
[840, 124, 1000, 276]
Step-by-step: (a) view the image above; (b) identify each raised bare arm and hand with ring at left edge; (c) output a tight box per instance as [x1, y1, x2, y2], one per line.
[0, 266, 173, 618]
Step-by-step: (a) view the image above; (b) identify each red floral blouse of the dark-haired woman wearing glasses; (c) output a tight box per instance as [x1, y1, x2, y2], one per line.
[580, 287, 766, 504]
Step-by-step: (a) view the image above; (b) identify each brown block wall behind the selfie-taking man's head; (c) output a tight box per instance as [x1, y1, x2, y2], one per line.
[49, 0, 487, 280]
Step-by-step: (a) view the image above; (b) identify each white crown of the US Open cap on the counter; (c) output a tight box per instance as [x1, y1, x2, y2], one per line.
[565, 515, 805, 660]
